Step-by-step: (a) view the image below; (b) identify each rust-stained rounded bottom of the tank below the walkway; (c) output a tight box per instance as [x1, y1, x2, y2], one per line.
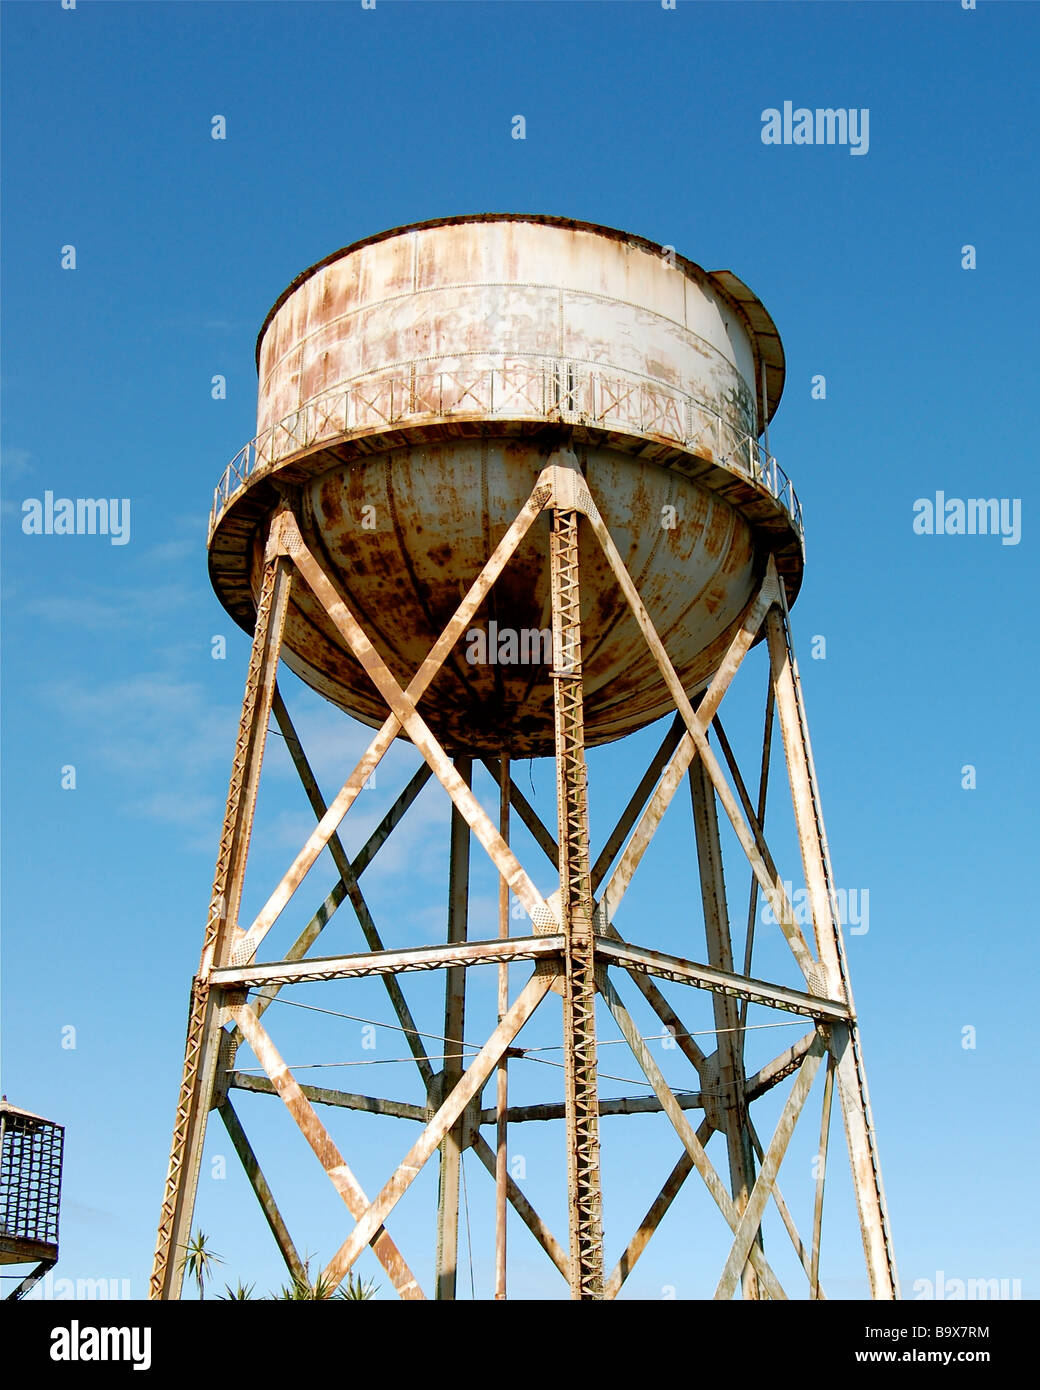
[253, 438, 761, 756]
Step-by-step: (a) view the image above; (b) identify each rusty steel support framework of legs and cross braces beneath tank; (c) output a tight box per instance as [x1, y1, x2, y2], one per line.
[150, 449, 898, 1300]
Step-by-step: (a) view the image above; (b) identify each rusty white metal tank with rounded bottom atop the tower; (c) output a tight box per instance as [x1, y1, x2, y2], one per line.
[209, 214, 804, 756]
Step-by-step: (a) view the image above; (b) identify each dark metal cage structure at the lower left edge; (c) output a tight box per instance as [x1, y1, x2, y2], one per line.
[0, 1098, 65, 1300]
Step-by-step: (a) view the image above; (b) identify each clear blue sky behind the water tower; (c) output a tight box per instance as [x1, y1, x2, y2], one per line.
[3, 0, 1040, 1298]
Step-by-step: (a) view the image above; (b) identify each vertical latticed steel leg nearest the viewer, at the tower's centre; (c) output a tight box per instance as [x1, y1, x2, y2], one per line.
[549, 464, 603, 1300]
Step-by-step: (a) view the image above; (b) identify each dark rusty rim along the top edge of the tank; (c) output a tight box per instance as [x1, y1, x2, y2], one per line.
[254, 213, 786, 424]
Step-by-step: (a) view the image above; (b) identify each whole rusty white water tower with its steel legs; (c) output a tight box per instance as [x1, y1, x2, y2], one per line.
[152, 214, 898, 1298]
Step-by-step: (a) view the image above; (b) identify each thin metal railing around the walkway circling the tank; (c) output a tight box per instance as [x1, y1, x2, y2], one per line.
[210, 359, 804, 535]
